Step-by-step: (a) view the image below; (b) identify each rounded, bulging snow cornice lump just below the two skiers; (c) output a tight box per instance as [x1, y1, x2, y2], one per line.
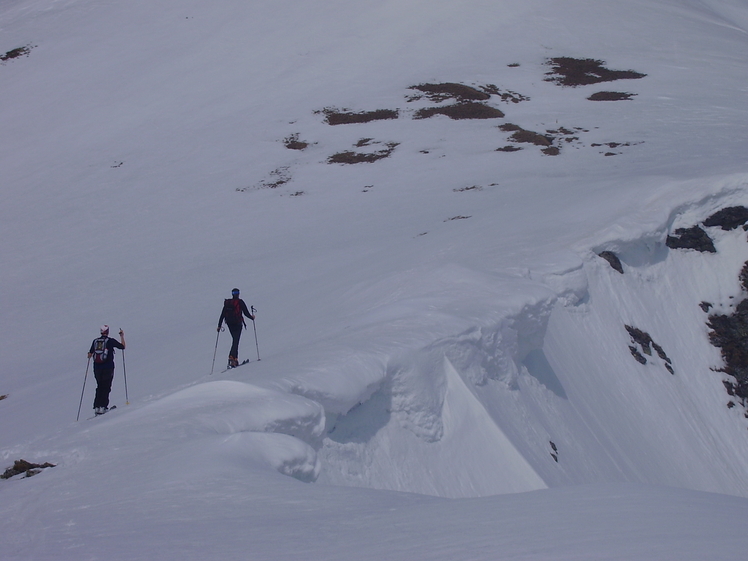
[54, 380, 325, 481]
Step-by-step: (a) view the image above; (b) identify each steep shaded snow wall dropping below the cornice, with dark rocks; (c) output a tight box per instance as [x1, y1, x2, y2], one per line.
[310, 177, 748, 497]
